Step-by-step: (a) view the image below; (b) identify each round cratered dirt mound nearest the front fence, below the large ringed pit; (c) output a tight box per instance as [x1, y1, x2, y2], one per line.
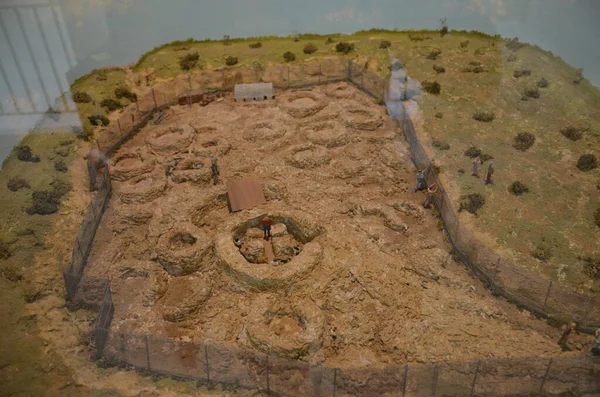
[245, 295, 325, 359]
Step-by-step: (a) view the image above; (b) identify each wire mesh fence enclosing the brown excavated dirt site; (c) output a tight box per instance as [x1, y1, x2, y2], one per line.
[64, 57, 600, 397]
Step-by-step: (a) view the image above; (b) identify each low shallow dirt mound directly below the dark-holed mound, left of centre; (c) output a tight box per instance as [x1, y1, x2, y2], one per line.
[157, 274, 212, 322]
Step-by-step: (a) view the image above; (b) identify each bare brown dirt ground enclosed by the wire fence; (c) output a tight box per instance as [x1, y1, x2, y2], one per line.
[77, 84, 583, 368]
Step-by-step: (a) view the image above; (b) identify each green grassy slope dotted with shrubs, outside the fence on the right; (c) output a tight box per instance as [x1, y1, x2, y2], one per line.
[393, 33, 600, 292]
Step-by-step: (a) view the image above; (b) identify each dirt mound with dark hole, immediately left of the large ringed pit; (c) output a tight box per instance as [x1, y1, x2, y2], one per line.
[154, 223, 214, 276]
